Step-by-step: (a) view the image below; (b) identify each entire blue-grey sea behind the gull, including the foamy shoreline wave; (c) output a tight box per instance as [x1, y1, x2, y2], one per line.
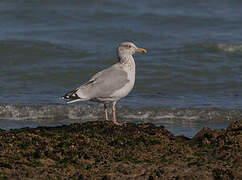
[0, 0, 242, 136]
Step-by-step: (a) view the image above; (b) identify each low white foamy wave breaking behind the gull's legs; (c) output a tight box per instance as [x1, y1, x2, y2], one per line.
[0, 104, 242, 123]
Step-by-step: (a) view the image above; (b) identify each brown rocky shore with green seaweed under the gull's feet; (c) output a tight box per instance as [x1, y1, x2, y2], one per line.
[0, 121, 242, 180]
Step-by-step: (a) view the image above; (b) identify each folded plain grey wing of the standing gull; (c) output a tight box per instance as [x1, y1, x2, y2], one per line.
[77, 65, 129, 99]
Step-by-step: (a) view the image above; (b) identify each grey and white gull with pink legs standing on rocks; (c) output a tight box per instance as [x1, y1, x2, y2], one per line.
[62, 42, 147, 125]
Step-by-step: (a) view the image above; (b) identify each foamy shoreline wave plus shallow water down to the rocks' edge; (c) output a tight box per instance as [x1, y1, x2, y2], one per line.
[0, 104, 239, 137]
